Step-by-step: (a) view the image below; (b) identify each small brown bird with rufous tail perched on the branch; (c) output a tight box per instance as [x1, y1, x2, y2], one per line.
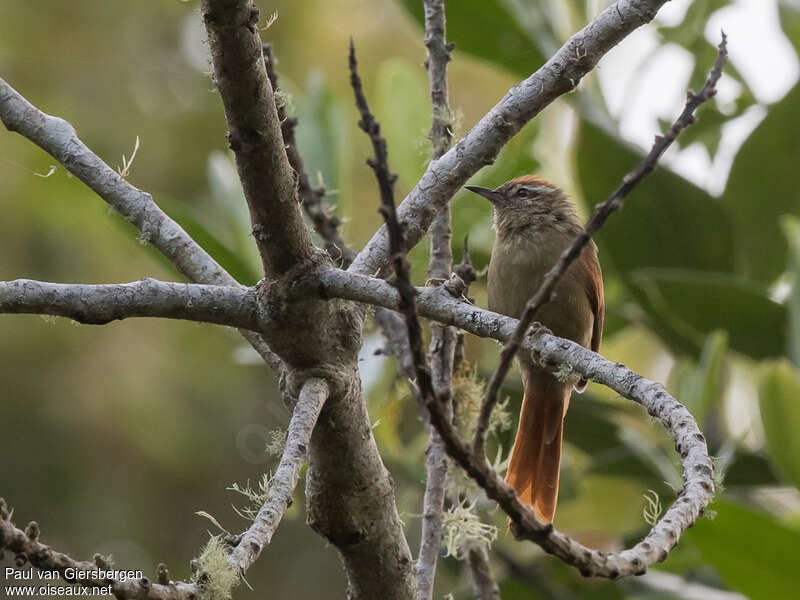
[466, 175, 605, 523]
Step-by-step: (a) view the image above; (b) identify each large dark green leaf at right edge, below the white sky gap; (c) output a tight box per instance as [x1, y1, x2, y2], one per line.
[723, 81, 800, 284]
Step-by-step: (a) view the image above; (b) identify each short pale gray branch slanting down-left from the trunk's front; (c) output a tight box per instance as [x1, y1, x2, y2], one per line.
[228, 377, 330, 573]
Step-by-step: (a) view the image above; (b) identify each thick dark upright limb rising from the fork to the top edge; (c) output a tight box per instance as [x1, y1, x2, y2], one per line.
[201, 0, 314, 276]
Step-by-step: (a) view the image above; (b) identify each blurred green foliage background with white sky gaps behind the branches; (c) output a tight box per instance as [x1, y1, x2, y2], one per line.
[0, 0, 800, 600]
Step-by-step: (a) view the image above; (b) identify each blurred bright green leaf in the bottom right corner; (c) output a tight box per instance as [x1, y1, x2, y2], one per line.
[686, 502, 800, 600]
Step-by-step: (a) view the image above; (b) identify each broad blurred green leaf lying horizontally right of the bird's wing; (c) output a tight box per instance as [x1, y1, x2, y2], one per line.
[630, 269, 788, 359]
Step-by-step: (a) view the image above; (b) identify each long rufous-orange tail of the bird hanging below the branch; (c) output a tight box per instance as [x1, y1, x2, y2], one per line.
[506, 369, 572, 523]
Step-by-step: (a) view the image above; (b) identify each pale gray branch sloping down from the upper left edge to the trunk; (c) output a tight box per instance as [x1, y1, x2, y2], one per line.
[0, 78, 283, 374]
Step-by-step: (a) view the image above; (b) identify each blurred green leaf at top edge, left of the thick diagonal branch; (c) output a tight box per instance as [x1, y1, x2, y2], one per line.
[399, 0, 545, 76]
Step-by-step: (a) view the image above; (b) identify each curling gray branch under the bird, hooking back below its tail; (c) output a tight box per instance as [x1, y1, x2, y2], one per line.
[319, 269, 714, 578]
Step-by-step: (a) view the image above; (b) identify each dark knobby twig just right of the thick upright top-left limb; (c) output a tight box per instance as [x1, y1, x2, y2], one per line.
[262, 44, 356, 269]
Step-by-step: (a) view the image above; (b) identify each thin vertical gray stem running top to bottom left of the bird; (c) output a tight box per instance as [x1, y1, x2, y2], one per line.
[414, 0, 456, 600]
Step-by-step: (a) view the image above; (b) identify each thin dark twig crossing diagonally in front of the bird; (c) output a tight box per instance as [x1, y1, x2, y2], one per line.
[473, 32, 728, 456]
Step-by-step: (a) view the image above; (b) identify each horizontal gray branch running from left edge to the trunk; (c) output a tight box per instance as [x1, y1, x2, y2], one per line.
[0, 279, 260, 331]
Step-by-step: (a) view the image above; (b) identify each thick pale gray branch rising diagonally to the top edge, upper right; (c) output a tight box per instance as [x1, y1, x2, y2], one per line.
[349, 0, 666, 275]
